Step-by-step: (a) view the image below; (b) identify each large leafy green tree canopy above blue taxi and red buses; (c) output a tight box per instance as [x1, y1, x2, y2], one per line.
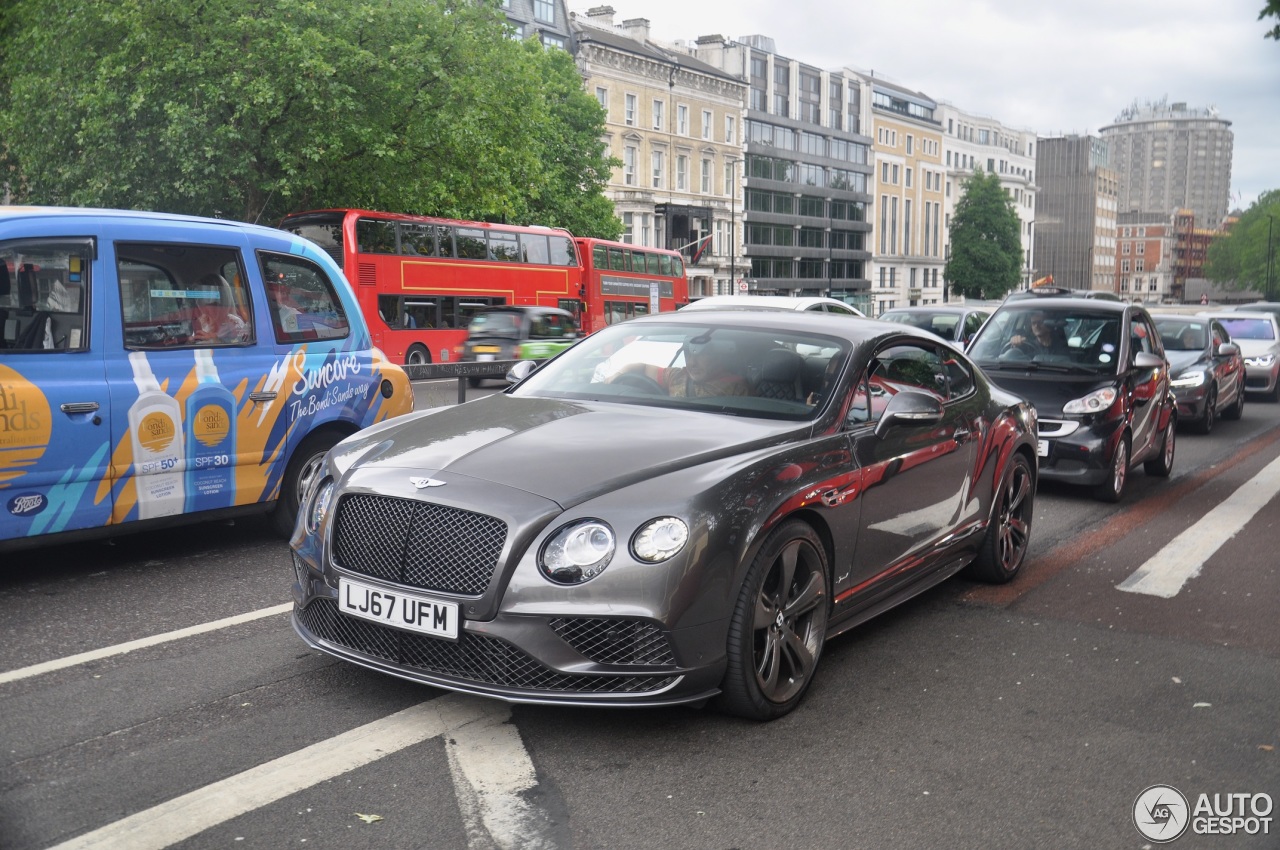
[0, 0, 621, 234]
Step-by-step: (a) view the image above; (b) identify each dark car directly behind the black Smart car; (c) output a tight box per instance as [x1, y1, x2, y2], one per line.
[1152, 312, 1244, 434]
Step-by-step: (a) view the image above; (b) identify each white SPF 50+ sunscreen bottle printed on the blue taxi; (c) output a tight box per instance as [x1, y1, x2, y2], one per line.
[129, 351, 183, 520]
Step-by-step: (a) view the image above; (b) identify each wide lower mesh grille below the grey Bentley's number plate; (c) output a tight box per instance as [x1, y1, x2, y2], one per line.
[298, 599, 676, 694]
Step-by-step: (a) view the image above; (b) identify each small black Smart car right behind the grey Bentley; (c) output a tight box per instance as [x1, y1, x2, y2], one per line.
[969, 298, 1178, 502]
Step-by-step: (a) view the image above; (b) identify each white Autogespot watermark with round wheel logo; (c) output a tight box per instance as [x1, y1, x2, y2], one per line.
[1133, 785, 1272, 844]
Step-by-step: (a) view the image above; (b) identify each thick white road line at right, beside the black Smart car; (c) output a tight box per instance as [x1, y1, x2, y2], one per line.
[1116, 450, 1280, 599]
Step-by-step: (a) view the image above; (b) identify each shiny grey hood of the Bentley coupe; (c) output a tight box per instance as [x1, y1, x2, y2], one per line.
[343, 394, 809, 507]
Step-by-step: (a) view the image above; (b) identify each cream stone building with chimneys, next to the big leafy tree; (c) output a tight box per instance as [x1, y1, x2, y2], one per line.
[570, 6, 746, 297]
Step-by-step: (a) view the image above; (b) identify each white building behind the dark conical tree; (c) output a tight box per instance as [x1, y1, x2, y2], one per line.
[940, 104, 1039, 288]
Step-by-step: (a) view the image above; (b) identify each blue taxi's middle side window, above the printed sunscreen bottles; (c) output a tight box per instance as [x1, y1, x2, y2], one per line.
[115, 242, 255, 349]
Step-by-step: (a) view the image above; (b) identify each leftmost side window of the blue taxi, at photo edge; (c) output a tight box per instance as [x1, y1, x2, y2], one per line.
[0, 239, 93, 352]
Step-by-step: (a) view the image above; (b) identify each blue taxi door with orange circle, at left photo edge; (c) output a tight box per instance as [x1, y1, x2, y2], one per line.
[0, 234, 113, 540]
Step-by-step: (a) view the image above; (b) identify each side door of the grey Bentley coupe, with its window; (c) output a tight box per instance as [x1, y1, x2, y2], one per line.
[836, 341, 980, 597]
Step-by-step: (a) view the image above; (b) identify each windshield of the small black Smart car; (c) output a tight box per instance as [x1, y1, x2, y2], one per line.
[969, 300, 1121, 373]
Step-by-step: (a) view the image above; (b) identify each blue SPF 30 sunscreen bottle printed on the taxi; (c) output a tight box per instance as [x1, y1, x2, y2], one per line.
[184, 348, 236, 512]
